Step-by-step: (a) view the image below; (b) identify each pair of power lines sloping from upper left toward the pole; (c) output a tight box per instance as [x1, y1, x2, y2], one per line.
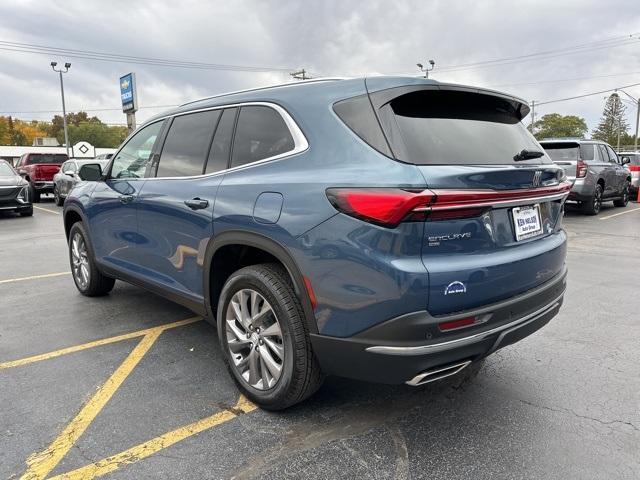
[0, 40, 292, 72]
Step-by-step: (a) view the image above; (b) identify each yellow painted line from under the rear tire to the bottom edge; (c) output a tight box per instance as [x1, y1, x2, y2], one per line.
[51, 396, 257, 480]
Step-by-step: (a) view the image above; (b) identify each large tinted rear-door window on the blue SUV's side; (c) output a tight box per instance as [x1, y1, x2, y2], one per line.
[156, 110, 220, 177]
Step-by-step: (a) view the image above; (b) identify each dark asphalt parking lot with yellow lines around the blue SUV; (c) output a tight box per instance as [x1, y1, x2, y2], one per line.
[0, 200, 640, 479]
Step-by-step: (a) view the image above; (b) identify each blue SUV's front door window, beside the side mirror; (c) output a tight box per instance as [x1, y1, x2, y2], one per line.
[110, 120, 163, 178]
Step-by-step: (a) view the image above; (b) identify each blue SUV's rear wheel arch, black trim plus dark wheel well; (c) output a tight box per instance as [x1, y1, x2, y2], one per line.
[203, 231, 318, 333]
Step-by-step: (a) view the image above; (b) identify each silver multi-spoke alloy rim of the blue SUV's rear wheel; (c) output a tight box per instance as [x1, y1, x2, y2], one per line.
[225, 288, 285, 390]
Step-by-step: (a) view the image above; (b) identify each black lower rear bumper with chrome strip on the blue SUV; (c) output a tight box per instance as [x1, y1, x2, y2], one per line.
[311, 269, 567, 384]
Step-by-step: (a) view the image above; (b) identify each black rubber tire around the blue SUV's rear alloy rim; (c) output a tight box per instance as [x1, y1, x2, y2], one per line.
[217, 263, 324, 410]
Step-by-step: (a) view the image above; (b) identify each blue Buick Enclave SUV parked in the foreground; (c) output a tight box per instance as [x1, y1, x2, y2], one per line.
[64, 77, 571, 409]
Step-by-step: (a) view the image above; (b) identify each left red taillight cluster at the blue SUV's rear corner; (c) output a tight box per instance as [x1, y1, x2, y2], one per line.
[327, 188, 435, 227]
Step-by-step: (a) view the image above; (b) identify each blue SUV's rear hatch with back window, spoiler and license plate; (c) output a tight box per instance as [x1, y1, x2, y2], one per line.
[368, 80, 575, 315]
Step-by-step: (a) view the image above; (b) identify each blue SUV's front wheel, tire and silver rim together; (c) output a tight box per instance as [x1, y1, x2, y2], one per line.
[69, 222, 116, 297]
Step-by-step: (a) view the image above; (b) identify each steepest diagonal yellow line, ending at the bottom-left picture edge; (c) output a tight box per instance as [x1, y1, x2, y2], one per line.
[20, 330, 162, 480]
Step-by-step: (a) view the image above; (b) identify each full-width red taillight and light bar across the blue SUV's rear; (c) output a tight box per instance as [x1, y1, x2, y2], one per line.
[327, 182, 572, 228]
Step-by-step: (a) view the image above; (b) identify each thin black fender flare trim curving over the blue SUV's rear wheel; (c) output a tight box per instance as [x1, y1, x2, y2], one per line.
[203, 230, 318, 333]
